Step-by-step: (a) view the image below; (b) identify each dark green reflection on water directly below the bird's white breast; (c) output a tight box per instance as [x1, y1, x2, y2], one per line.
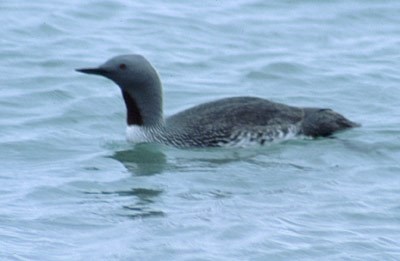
[111, 144, 167, 176]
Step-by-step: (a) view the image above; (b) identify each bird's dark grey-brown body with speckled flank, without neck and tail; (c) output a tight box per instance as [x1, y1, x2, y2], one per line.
[166, 97, 303, 146]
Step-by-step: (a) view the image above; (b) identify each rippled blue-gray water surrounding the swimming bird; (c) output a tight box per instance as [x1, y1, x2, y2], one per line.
[0, 0, 400, 260]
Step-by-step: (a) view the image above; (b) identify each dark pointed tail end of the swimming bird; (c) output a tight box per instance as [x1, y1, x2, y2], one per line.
[301, 108, 361, 137]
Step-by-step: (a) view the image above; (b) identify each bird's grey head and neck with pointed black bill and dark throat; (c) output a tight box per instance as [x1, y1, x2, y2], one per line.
[77, 54, 163, 126]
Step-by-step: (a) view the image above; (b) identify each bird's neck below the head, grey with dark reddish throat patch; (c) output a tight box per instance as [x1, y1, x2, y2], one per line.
[122, 90, 164, 127]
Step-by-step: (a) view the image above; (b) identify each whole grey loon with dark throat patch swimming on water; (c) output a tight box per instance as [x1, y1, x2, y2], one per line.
[77, 54, 359, 147]
